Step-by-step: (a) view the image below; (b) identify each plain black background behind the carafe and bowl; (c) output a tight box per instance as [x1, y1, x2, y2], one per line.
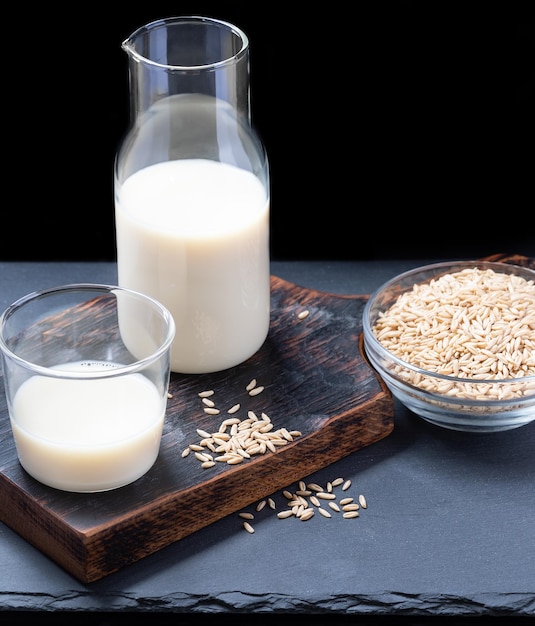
[5, 0, 535, 260]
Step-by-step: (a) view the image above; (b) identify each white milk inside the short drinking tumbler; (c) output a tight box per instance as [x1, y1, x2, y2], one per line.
[10, 364, 165, 492]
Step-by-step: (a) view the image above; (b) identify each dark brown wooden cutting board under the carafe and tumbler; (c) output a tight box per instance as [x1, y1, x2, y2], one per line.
[0, 255, 526, 583]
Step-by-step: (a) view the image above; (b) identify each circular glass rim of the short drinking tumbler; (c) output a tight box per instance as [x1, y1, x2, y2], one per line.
[0, 283, 176, 380]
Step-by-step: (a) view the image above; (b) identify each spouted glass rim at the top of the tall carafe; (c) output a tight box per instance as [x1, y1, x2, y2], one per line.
[121, 15, 249, 72]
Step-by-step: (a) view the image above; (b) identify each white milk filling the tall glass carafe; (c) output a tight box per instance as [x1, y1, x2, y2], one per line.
[116, 159, 270, 374]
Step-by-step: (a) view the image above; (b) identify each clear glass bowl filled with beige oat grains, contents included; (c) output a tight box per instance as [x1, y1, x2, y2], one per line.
[363, 261, 535, 431]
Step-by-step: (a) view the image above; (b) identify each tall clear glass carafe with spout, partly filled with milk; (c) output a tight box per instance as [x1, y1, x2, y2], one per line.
[114, 16, 270, 374]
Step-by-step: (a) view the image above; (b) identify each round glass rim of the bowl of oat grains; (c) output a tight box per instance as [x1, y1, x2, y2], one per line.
[362, 260, 535, 386]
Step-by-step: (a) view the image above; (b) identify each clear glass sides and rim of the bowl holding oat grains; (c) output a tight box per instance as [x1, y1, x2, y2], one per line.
[363, 261, 535, 432]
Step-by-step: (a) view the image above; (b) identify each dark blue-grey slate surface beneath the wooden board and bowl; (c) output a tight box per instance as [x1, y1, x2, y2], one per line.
[0, 259, 535, 624]
